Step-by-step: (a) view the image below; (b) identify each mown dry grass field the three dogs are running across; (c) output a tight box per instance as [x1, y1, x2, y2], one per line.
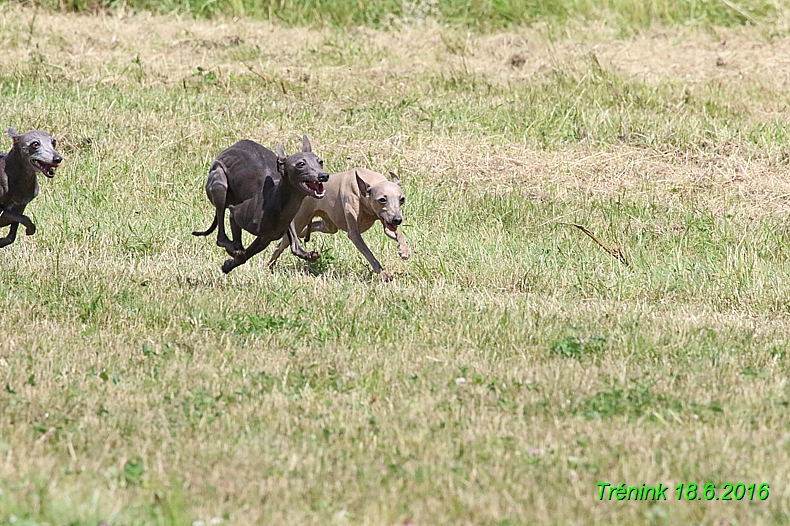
[0, 2, 790, 526]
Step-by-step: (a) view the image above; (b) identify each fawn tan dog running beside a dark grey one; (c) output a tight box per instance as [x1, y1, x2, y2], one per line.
[269, 168, 411, 281]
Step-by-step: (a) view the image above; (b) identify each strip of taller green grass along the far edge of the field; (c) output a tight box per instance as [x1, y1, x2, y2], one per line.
[10, 0, 788, 33]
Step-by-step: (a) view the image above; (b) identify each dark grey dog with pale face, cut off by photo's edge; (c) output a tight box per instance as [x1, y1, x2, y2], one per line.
[0, 128, 63, 248]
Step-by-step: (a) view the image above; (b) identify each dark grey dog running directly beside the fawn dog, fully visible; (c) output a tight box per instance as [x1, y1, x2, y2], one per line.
[192, 135, 329, 274]
